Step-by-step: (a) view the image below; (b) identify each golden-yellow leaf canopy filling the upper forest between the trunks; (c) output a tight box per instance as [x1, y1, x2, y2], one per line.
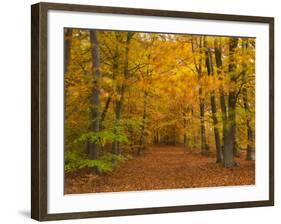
[65, 29, 255, 163]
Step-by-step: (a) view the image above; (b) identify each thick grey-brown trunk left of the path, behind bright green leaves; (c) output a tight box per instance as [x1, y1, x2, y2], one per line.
[89, 30, 101, 159]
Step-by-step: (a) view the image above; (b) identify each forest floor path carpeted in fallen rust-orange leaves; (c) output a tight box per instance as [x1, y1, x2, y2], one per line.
[65, 145, 255, 194]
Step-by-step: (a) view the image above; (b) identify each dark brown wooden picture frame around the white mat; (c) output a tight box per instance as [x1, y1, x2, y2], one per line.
[31, 3, 274, 221]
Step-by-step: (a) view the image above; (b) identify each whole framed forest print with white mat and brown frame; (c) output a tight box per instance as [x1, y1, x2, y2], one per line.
[31, 3, 274, 221]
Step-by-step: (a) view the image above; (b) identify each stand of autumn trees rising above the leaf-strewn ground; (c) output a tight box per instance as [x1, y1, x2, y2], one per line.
[64, 28, 255, 173]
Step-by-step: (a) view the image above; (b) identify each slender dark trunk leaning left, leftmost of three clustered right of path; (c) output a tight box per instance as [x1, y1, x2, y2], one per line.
[204, 40, 222, 163]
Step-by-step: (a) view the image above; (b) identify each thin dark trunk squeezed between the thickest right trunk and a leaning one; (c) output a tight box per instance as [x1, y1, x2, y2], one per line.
[214, 39, 227, 159]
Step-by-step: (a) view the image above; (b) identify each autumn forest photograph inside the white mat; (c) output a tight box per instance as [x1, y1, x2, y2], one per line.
[63, 28, 256, 194]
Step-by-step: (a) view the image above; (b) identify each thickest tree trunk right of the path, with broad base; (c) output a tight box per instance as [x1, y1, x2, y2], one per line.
[224, 38, 238, 167]
